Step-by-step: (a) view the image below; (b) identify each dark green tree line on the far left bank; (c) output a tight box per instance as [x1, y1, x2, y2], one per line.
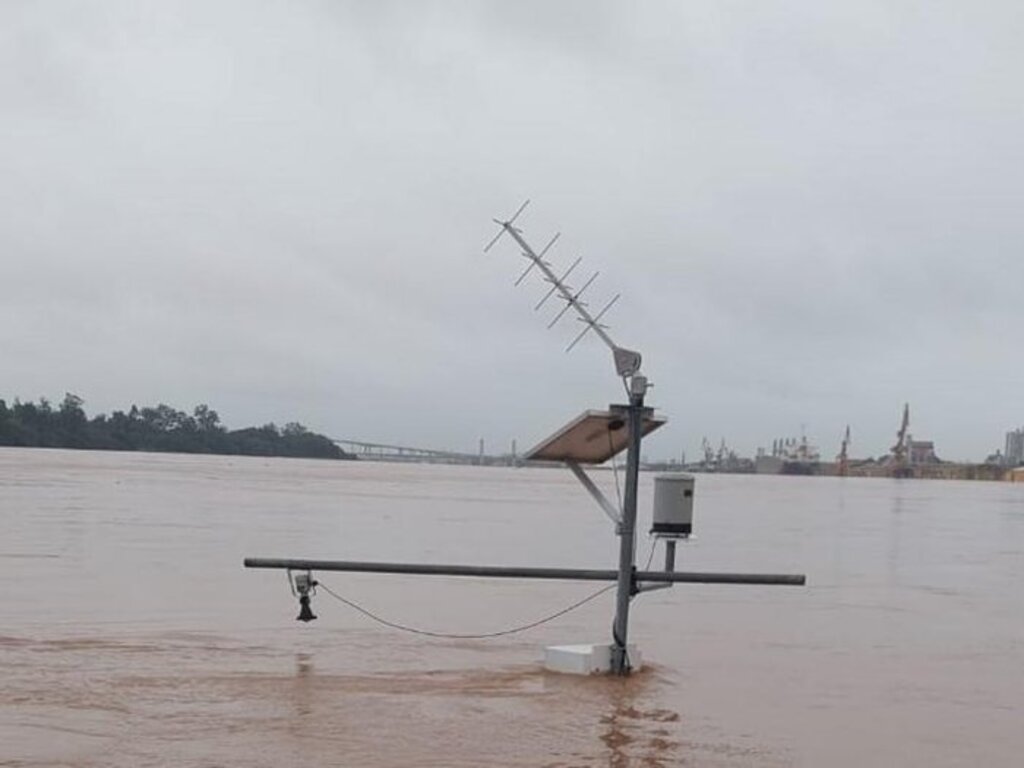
[0, 392, 355, 459]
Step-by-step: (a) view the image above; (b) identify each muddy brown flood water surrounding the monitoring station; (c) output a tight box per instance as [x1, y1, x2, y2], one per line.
[0, 449, 1024, 768]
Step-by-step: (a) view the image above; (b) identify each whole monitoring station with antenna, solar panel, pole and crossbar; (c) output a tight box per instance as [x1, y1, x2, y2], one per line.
[245, 201, 806, 675]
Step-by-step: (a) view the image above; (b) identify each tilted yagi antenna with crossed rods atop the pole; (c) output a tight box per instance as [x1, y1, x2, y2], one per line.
[483, 200, 641, 379]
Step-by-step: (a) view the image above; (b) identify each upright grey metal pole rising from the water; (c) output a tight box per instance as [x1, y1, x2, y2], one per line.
[611, 376, 647, 675]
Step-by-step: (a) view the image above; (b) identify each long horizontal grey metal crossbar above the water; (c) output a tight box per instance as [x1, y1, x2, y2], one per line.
[245, 557, 807, 587]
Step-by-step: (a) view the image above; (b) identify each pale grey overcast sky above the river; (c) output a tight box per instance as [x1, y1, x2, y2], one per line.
[0, 0, 1024, 460]
